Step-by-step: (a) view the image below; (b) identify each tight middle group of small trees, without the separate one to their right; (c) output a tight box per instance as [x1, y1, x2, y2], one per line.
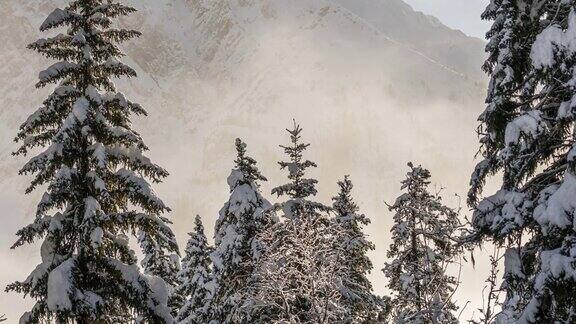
[177, 125, 387, 323]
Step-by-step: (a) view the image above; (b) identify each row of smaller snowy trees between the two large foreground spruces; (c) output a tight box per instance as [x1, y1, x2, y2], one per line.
[166, 123, 460, 323]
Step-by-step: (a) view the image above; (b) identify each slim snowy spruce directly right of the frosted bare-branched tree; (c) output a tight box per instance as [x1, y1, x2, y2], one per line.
[332, 176, 385, 323]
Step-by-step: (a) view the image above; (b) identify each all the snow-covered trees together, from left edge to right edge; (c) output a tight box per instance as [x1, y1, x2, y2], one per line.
[9, 0, 576, 324]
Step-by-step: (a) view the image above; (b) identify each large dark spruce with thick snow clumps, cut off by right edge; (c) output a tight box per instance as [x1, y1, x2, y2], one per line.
[469, 0, 576, 323]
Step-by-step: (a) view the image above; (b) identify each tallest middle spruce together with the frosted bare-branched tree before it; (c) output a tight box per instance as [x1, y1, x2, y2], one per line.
[241, 123, 345, 323]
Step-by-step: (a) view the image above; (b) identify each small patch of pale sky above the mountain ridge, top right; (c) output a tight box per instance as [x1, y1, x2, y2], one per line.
[404, 0, 490, 38]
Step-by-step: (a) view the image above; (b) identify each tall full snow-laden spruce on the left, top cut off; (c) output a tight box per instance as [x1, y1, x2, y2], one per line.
[7, 0, 178, 323]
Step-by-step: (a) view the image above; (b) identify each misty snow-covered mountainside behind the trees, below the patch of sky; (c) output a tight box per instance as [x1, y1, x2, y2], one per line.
[0, 0, 485, 318]
